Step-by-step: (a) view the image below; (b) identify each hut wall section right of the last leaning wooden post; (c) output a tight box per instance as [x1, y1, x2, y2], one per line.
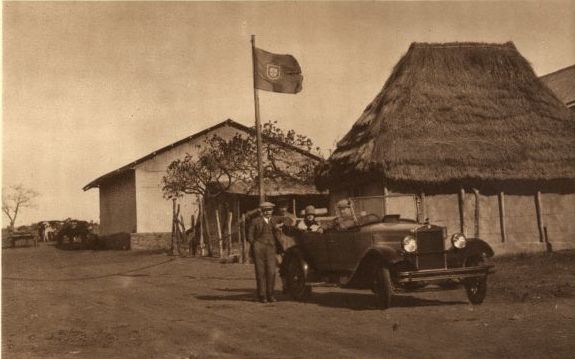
[541, 193, 575, 250]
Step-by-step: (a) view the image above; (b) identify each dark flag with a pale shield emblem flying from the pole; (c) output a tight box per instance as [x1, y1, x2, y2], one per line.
[254, 48, 303, 94]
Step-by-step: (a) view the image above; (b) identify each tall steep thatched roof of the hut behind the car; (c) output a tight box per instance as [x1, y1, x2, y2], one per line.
[317, 42, 575, 193]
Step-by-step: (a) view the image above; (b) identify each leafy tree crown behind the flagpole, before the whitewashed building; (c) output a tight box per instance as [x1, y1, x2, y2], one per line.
[163, 122, 320, 198]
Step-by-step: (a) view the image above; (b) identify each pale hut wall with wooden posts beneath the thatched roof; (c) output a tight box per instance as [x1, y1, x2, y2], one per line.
[330, 180, 575, 254]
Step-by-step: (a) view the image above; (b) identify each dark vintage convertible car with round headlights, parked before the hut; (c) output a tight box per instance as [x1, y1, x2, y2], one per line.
[280, 207, 493, 309]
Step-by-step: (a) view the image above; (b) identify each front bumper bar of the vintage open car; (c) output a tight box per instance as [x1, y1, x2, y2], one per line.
[397, 265, 495, 283]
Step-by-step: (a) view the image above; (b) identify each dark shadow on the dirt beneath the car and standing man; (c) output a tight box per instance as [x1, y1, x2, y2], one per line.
[196, 288, 467, 310]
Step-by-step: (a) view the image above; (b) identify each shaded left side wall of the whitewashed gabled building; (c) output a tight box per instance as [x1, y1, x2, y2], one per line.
[99, 171, 137, 235]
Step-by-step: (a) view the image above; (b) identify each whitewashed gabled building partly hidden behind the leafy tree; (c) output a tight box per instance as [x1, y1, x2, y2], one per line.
[83, 119, 327, 249]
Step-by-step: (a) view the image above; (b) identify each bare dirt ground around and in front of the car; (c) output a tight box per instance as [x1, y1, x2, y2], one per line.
[2, 244, 575, 359]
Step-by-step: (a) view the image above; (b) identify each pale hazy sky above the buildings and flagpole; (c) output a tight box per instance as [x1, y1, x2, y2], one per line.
[2, 1, 575, 225]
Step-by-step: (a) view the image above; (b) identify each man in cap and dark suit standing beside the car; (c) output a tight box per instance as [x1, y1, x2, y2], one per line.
[248, 202, 282, 303]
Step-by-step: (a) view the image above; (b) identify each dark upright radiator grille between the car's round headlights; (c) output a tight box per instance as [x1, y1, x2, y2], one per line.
[416, 228, 445, 269]
